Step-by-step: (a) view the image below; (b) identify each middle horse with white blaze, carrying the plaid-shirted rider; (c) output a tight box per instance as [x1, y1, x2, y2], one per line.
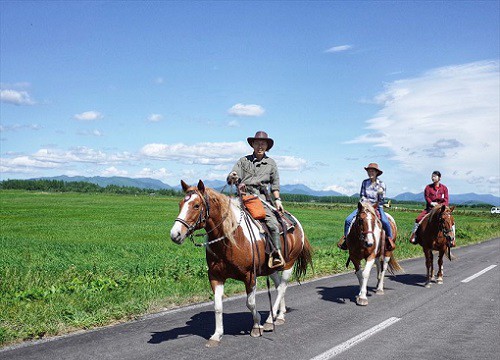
[346, 202, 402, 306]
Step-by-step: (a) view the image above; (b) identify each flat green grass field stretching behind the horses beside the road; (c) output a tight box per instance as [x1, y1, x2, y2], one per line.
[0, 190, 500, 345]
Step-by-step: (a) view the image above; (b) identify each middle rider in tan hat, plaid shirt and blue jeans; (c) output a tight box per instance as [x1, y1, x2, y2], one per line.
[338, 163, 395, 250]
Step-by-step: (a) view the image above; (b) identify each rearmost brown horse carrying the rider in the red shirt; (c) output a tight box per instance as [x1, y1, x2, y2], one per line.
[415, 205, 455, 288]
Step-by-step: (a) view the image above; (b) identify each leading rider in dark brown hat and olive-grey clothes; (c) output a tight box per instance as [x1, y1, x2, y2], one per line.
[227, 131, 285, 268]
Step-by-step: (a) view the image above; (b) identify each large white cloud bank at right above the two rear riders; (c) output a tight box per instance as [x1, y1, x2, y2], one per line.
[347, 61, 500, 191]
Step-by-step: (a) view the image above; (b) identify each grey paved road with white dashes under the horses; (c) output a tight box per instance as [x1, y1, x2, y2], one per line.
[0, 239, 500, 360]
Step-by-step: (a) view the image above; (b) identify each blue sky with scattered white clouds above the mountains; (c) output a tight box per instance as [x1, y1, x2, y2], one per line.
[0, 0, 500, 196]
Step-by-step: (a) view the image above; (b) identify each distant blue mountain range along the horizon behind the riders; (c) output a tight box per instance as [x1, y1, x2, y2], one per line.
[33, 175, 500, 206]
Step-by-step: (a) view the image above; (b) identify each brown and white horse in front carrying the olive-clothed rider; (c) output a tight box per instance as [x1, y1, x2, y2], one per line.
[170, 180, 312, 347]
